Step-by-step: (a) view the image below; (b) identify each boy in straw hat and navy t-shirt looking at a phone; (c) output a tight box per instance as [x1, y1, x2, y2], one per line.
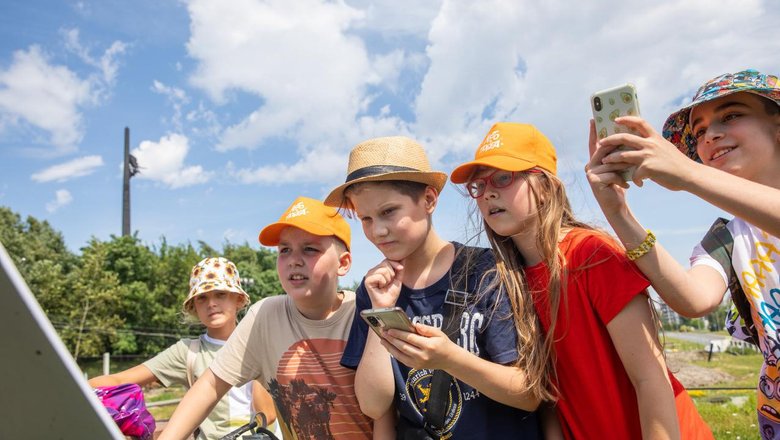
[325, 136, 541, 439]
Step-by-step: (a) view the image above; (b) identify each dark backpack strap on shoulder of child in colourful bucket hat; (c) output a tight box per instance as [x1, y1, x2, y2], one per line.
[701, 218, 758, 345]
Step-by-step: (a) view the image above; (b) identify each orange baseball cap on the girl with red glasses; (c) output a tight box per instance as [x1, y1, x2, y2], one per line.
[450, 122, 558, 183]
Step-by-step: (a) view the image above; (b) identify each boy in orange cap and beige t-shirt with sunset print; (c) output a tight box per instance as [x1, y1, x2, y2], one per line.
[160, 197, 372, 439]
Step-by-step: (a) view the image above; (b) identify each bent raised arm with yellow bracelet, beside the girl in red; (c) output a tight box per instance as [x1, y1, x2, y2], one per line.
[585, 117, 726, 317]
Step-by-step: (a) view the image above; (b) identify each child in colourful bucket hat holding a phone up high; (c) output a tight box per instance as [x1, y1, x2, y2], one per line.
[586, 70, 780, 439]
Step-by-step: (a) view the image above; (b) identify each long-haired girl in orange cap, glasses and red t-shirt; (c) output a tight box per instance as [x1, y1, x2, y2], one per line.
[450, 122, 711, 439]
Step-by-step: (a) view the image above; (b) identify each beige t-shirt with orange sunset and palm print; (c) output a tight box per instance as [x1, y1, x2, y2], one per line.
[211, 291, 372, 439]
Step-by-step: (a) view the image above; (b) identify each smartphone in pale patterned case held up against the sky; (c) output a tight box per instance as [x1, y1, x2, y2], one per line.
[590, 84, 639, 182]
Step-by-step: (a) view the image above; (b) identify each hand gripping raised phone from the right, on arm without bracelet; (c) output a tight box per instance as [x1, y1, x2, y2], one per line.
[598, 116, 701, 191]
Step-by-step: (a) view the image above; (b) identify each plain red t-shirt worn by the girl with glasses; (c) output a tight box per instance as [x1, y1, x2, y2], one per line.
[525, 229, 684, 439]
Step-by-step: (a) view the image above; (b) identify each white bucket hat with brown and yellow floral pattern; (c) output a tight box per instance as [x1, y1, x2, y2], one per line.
[182, 257, 250, 314]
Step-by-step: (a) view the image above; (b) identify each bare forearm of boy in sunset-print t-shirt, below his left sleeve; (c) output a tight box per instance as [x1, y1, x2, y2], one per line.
[159, 368, 231, 440]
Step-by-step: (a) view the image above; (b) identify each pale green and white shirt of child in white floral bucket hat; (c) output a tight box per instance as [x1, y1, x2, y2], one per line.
[144, 334, 252, 439]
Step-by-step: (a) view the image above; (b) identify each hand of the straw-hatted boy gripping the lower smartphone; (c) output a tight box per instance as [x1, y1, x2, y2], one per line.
[382, 323, 462, 370]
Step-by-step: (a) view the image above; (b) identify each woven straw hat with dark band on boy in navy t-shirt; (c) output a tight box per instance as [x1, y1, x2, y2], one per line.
[325, 136, 447, 207]
